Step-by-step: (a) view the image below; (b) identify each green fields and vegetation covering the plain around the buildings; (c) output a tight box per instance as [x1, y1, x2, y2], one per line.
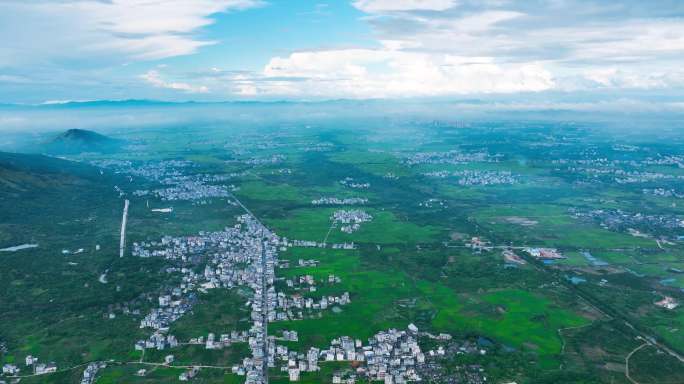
[0, 112, 684, 384]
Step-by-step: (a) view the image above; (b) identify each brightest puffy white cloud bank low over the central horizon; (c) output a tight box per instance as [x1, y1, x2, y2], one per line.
[250, 49, 554, 98]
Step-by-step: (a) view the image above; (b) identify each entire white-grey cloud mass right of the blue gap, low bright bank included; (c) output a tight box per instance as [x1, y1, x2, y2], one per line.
[228, 0, 684, 98]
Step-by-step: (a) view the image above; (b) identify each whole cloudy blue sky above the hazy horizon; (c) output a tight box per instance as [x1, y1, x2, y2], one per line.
[0, 0, 684, 104]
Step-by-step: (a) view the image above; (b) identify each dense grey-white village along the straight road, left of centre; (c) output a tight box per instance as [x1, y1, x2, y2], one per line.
[128, 215, 281, 383]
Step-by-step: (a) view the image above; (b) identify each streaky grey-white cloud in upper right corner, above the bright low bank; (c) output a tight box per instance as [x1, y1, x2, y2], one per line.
[348, 0, 684, 92]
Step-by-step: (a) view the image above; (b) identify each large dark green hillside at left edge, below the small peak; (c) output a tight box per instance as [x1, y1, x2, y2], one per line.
[0, 152, 123, 248]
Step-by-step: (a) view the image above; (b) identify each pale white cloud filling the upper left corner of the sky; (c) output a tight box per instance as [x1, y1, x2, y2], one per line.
[0, 0, 262, 66]
